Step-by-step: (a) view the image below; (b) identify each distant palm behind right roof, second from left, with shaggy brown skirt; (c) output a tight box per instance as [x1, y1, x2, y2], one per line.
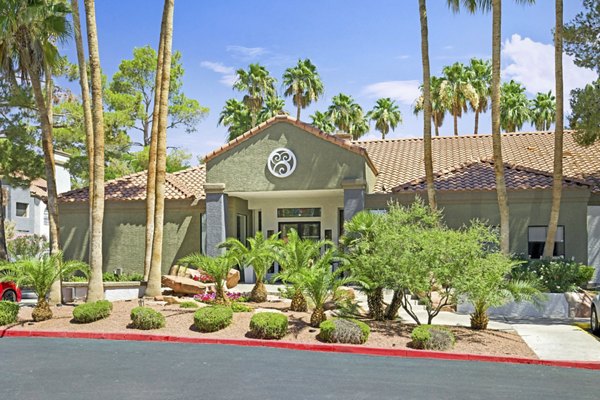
[440, 62, 479, 136]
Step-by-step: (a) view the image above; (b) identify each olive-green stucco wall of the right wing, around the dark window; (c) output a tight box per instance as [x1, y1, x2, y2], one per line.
[366, 190, 589, 263]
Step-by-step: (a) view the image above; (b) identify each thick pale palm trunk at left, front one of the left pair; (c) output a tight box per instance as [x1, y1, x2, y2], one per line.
[84, 0, 104, 302]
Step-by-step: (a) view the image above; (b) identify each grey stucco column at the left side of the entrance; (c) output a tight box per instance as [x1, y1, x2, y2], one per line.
[204, 183, 227, 257]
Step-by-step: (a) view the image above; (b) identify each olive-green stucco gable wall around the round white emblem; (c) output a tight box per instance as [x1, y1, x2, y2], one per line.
[206, 123, 373, 192]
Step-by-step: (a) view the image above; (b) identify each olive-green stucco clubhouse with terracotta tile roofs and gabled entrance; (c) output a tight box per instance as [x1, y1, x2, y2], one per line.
[59, 116, 600, 282]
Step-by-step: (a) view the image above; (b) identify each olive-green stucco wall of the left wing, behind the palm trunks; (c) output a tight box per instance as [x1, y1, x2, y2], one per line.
[59, 200, 203, 273]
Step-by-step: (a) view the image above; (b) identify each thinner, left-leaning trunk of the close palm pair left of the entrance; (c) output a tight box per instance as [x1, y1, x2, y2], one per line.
[144, 15, 165, 281]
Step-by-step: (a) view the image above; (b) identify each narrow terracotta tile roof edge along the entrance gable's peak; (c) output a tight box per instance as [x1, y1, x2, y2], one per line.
[204, 115, 379, 175]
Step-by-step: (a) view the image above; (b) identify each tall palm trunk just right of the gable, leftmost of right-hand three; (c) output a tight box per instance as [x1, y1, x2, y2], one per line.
[419, 0, 437, 209]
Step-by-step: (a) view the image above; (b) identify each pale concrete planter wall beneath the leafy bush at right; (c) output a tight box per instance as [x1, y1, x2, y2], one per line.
[457, 293, 585, 319]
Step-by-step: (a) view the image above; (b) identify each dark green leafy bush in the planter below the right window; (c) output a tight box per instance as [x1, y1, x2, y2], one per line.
[511, 260, 594, 293]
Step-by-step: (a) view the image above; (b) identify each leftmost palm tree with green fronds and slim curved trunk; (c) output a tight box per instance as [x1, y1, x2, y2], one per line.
[0, 0, 70, 303]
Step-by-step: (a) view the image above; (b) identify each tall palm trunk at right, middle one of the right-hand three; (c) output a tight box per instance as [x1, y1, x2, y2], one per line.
[492, 0, 510, 254]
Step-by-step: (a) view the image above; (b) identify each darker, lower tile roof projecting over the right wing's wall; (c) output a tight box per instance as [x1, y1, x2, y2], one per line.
[392, 159, 589, 193]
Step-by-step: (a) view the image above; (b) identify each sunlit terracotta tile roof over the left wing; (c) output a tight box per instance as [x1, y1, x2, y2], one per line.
[59, 165, 205, 203]
